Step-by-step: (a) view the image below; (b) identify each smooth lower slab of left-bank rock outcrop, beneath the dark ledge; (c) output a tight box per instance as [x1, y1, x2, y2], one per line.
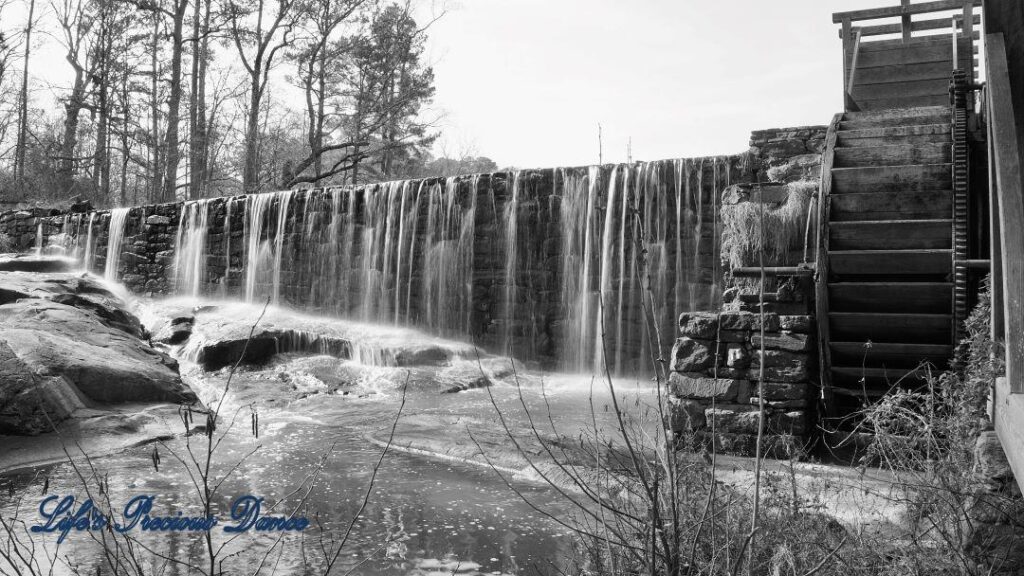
[0, 298, 196, 435]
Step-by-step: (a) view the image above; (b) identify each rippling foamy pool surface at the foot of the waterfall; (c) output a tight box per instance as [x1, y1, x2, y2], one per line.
[0, 297, 651, 576]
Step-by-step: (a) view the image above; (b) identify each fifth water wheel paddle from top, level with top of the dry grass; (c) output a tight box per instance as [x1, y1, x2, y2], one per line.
[829, 190, 953, 225]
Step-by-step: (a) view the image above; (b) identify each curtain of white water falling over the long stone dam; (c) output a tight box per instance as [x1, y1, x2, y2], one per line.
[79, 159, 731, 374]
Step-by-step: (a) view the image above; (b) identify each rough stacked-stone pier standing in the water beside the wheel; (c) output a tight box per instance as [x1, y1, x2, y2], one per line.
[669, 275, 818, 457]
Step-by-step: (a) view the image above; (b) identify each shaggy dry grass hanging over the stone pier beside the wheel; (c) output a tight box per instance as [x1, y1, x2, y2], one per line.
[722, 180, 817, 268]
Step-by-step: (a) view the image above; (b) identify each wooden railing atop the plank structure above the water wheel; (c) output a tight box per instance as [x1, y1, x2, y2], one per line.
[833, 0, 982, 111]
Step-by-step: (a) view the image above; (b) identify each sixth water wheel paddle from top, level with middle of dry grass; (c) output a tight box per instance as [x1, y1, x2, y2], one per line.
[828, 219, 953, 250]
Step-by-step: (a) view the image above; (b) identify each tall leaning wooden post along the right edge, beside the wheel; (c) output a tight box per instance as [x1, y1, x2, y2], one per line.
[985, 33, 1024, 391]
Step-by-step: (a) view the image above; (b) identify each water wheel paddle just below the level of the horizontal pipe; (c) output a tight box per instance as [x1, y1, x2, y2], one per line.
[828, 282, 953, 314]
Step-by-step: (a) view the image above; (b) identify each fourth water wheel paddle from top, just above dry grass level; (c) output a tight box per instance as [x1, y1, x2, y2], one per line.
[831, 163, 952, 194]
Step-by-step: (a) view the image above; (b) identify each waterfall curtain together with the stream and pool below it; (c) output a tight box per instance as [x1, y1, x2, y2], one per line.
[6, 158, 731, 574]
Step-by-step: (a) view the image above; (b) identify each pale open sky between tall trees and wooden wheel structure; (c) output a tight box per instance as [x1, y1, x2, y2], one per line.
[419, 0, 899, 168]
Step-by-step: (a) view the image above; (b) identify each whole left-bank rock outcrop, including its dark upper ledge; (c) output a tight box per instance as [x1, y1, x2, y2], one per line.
[0, 255, 197, 436]
